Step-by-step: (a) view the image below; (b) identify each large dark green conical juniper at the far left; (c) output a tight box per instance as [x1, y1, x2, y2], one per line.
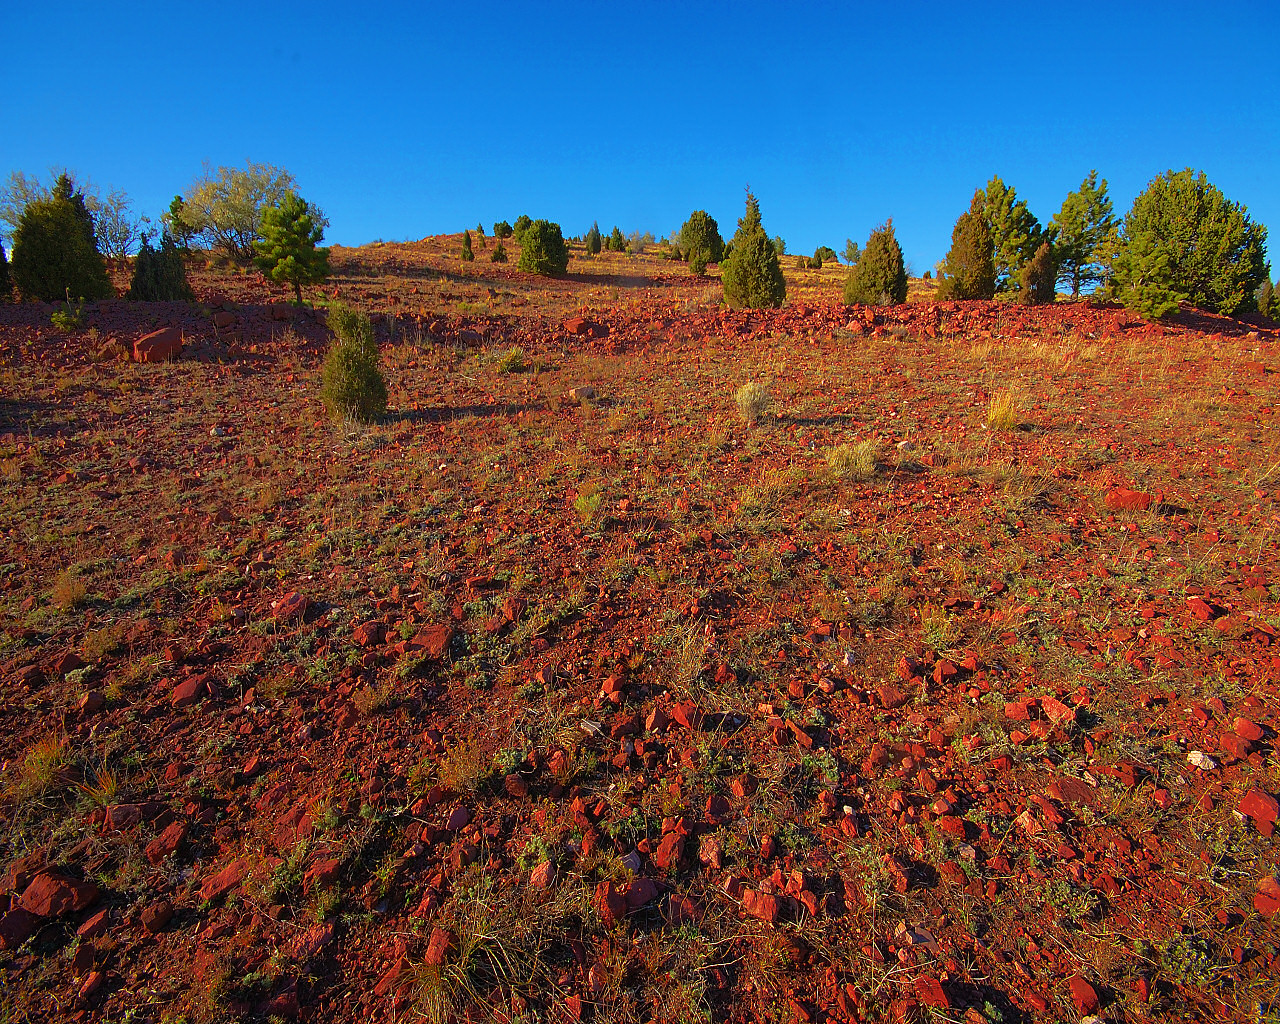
[13, 185, 114, 302]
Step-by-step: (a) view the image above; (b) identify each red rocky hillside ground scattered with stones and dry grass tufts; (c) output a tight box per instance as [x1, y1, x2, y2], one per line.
[0, 238, 1280, 1024]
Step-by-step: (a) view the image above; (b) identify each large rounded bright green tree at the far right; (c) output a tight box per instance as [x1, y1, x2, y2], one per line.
[1114, 168, 1267, 317]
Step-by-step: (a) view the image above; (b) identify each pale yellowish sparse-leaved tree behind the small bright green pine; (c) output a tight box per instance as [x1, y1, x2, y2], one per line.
[182, 163, 294, 264]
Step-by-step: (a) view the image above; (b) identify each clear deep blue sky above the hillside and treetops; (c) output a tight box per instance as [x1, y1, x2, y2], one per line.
[0, 0, 1280, 273]
